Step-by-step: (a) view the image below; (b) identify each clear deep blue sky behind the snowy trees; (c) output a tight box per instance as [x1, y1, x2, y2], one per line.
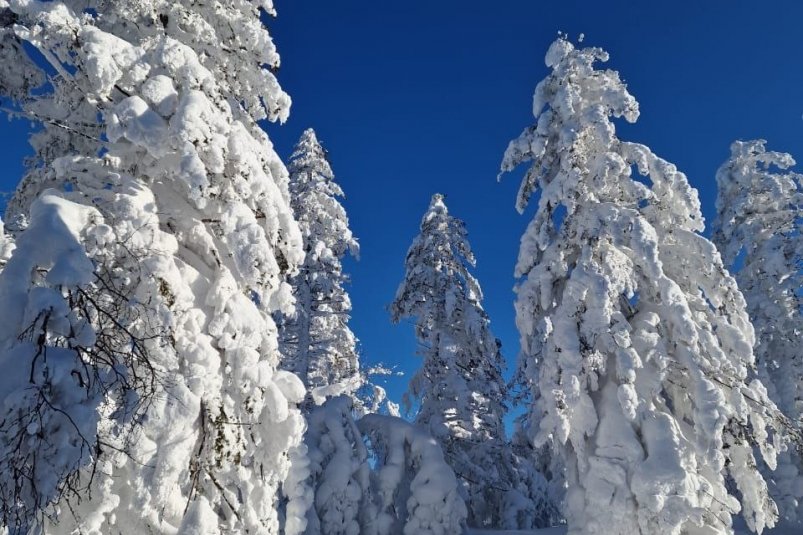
[0, 0, 803, 418]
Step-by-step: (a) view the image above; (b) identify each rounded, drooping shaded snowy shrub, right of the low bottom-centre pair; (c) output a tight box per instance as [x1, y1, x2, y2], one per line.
[357, 414, 467, 535]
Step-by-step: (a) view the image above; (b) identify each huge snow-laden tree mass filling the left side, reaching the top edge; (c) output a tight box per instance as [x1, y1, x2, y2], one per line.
[0, 0, 304, 534]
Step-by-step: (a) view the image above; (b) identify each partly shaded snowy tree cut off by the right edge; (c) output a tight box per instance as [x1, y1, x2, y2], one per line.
[713, 140, 803, 523]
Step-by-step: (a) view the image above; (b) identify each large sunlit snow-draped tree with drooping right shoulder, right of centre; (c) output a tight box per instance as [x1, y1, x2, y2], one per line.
[502, 37, 788, 535]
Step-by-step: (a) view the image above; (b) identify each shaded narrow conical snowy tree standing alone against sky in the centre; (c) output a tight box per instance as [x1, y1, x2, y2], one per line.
[390, 194, 512, 526]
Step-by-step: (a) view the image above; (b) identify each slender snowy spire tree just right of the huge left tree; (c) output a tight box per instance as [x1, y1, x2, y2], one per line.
[279, 129, 362, 405]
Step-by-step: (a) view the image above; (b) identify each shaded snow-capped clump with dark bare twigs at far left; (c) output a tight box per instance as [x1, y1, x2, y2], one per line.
[0, 190, 107, 525]
